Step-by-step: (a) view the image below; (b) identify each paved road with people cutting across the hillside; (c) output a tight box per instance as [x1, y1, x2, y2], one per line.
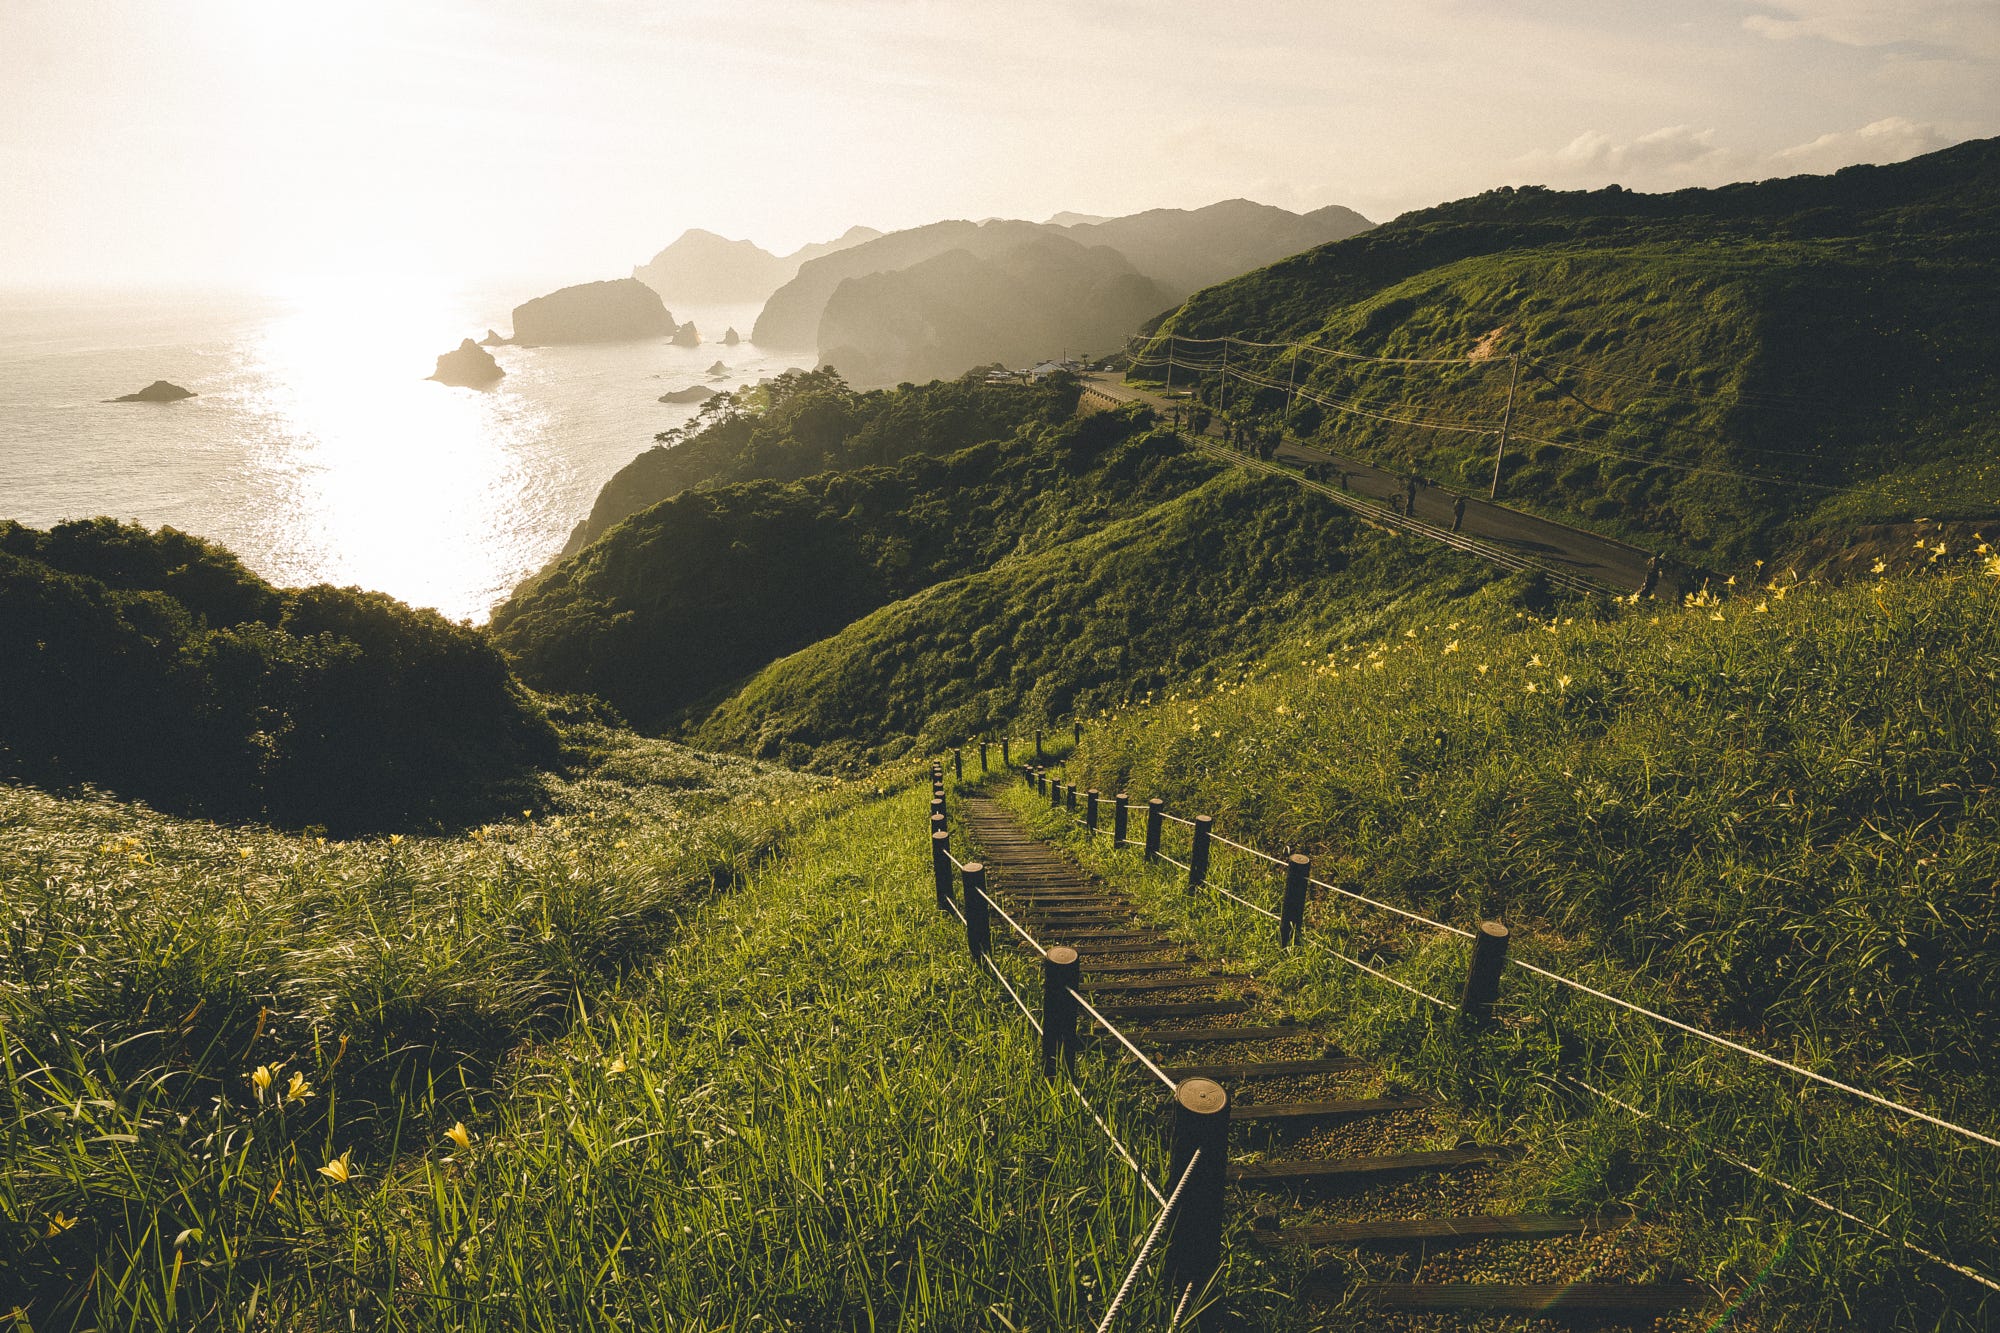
[1084, 374, 1676, 594]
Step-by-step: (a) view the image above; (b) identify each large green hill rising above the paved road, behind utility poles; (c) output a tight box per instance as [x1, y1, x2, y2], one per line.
[1144, 140, 2000, 568]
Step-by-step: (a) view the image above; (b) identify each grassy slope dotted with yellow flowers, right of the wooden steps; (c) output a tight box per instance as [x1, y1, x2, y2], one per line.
[1040, 558, 2000, 1329]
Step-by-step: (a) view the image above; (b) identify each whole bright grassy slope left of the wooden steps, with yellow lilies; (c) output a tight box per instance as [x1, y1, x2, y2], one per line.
[0, 764, 1298, 1331]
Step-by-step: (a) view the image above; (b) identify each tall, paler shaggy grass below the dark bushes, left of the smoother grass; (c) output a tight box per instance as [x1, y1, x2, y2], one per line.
[0, 727, 844, 1329]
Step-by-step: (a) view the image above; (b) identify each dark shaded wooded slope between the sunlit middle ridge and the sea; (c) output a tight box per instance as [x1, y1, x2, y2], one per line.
[492, 412, 1216, 727]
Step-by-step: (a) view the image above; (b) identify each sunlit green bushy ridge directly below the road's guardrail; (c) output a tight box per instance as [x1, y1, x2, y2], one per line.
[694, 464, 1494, 767]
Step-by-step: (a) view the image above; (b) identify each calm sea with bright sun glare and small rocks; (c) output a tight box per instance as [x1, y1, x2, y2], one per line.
[0, 286, 802, 620]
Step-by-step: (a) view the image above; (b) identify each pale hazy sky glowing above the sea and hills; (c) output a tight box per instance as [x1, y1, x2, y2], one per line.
[0, 0, 2000, 284]
